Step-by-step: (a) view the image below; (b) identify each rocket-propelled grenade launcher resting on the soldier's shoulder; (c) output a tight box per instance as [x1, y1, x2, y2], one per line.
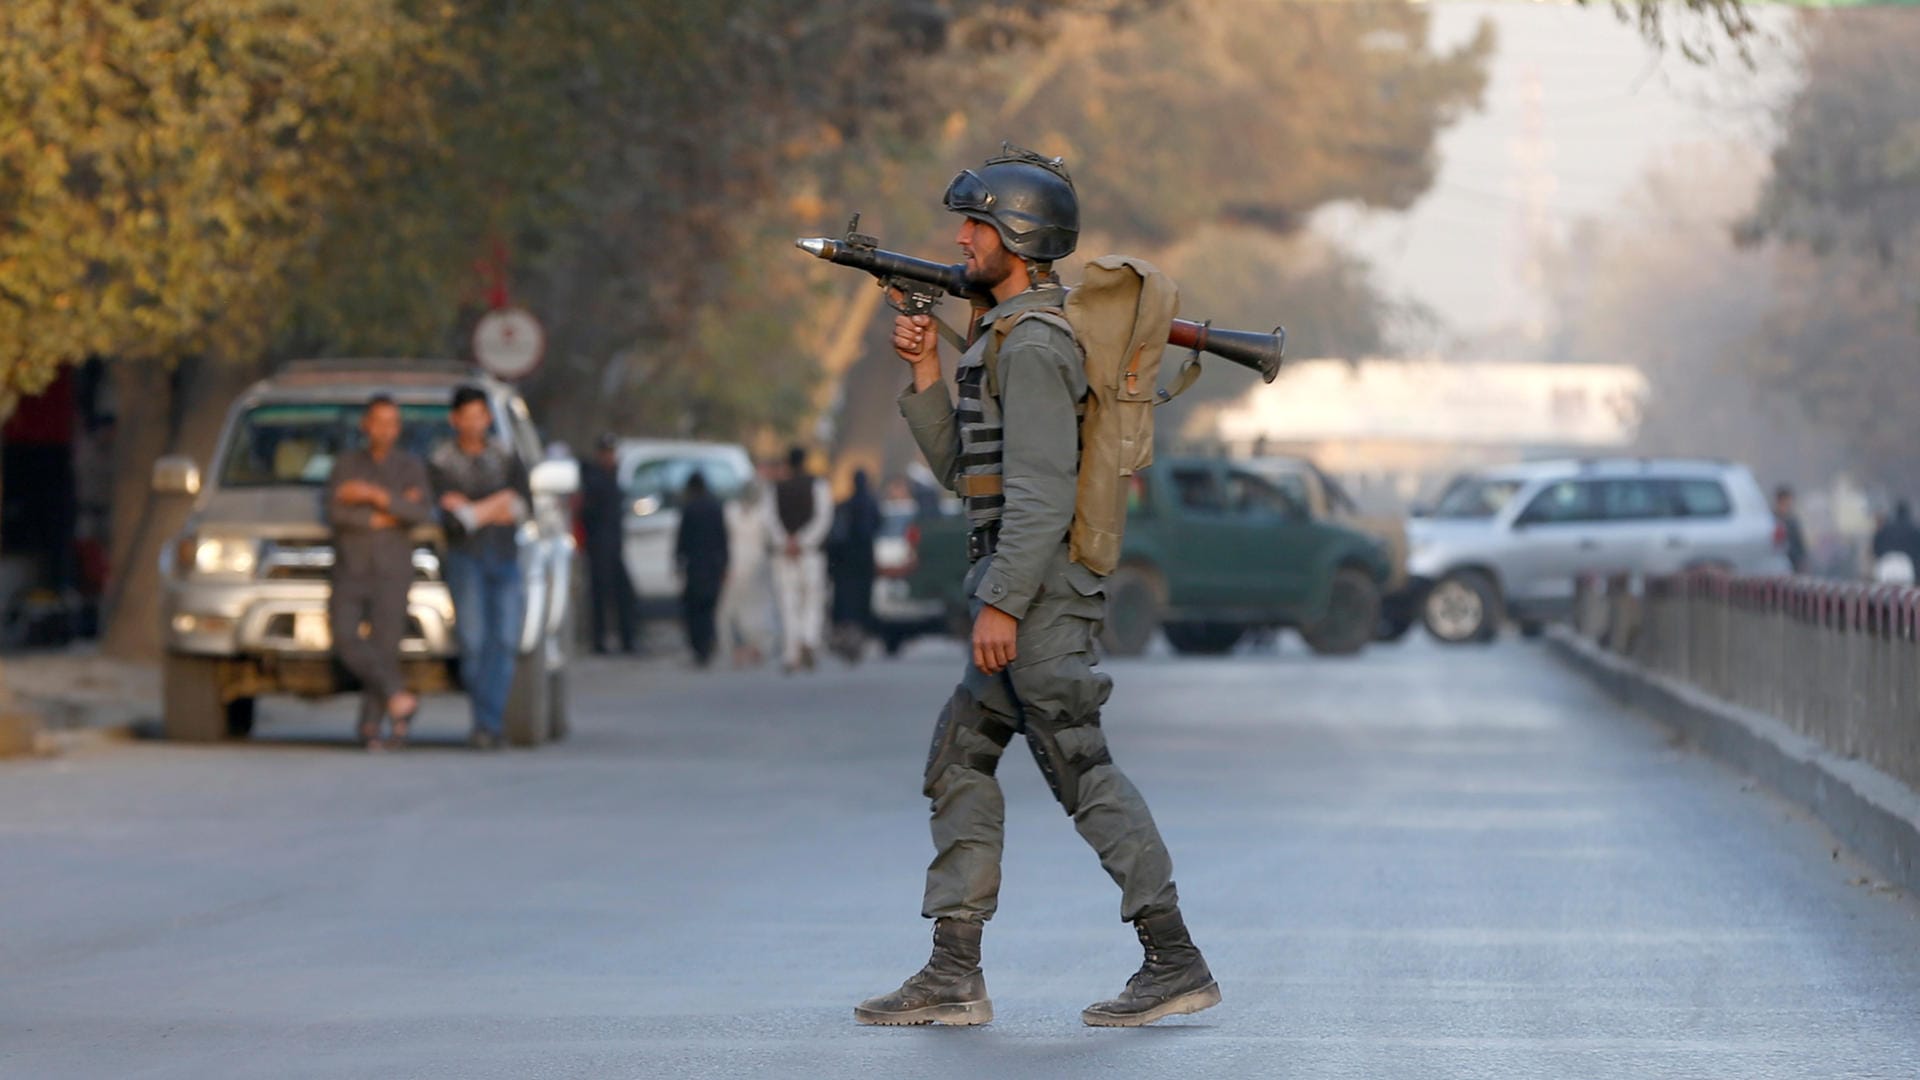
[793, 213, 1286, 382]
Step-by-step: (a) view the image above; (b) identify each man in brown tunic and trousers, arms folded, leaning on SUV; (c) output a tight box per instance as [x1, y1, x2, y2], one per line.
[326, 394, 434, 749]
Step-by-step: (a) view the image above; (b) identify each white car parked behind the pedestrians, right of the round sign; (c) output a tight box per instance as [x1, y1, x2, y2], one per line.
[614, 438, 753, 617]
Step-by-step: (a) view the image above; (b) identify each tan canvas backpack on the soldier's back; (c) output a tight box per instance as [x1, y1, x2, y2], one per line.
[985, 256, 1200, 575]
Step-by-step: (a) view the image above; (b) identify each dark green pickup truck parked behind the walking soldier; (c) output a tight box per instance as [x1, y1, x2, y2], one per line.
[912, 457, 1392, 655]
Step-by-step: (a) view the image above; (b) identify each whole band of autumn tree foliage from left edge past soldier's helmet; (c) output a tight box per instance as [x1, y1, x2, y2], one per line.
[0, 0, 1492, 436]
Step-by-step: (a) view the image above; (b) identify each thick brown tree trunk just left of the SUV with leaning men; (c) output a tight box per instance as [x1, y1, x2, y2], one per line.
[100, 361, 257, 659]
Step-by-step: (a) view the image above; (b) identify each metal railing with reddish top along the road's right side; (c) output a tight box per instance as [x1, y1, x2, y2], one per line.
[1574, 573, 1920, 790]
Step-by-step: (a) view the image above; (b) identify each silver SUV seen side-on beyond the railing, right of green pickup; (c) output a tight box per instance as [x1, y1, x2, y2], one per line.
[1407, 451, 1788, 644]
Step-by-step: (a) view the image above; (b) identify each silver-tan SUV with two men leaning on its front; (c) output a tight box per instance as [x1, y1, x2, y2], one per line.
[154, 359, 580, 746]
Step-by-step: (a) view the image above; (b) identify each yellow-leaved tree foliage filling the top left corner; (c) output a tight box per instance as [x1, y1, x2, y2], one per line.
[0, 0, 434, 392]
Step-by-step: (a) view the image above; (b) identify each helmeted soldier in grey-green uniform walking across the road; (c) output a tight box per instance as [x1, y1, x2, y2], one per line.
[854, 148, 1219, 1026]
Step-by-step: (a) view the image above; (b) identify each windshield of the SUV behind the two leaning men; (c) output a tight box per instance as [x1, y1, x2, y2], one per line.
[219, 402, 453, 488]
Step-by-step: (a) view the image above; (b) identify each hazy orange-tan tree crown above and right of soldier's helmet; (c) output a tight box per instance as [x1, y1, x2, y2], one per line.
[975, 0, 1494, 242]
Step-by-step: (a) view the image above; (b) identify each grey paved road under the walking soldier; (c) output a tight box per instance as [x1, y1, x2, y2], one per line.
[0, 642, 1920, 1080]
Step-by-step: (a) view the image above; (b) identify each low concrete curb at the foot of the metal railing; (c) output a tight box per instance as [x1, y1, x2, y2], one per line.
[1548, 626, 1920, 894]
